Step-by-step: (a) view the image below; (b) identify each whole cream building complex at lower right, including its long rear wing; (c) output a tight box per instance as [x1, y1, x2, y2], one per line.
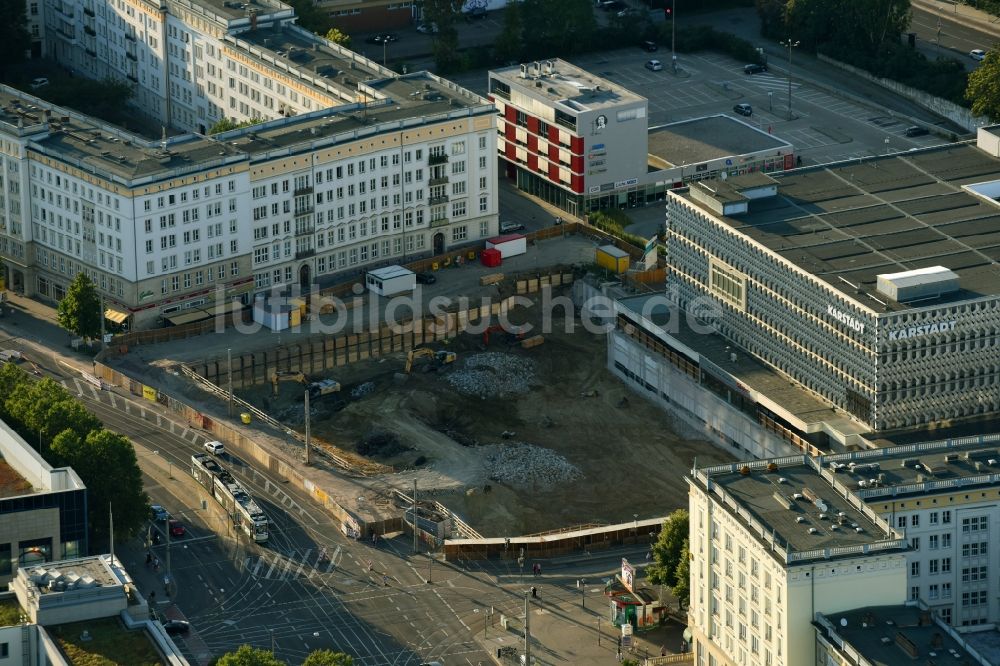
[689, 435, 1000, 666]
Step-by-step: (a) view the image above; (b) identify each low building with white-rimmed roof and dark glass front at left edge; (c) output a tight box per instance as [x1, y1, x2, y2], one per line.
[0, 422, 88, 587]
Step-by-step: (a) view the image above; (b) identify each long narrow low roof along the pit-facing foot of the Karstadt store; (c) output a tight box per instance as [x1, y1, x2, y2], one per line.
[618, 294, 868, 434]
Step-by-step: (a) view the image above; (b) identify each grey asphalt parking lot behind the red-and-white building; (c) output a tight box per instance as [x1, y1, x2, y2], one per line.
[442, 47, 945, 164]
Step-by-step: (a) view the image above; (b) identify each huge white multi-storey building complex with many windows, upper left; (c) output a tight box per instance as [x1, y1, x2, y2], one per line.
[0, 2, 497, 328]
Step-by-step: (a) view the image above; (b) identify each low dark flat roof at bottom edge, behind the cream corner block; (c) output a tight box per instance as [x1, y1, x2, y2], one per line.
[823, 605, 984, 666]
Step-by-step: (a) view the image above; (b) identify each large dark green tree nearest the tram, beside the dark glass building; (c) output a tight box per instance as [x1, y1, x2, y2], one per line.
[52, 429, 149, 552]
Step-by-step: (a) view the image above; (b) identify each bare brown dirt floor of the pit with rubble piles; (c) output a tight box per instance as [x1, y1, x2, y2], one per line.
[234, 300, 732, 536]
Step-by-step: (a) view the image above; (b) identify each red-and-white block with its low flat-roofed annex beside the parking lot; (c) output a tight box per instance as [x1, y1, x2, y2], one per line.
[489, 59, 794, 216]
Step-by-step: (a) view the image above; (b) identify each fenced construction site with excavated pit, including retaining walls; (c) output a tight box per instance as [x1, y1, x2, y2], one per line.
[103, 262, 731, 537]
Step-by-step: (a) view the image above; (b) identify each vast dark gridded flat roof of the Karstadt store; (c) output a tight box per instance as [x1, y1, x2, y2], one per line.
[676, 144, 1000, 313]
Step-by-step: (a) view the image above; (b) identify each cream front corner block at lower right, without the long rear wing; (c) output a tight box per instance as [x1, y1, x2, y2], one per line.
[688, 456, 907, 666]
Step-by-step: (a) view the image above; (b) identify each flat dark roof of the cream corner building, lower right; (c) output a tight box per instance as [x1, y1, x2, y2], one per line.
[707, 456, 894, 553]
